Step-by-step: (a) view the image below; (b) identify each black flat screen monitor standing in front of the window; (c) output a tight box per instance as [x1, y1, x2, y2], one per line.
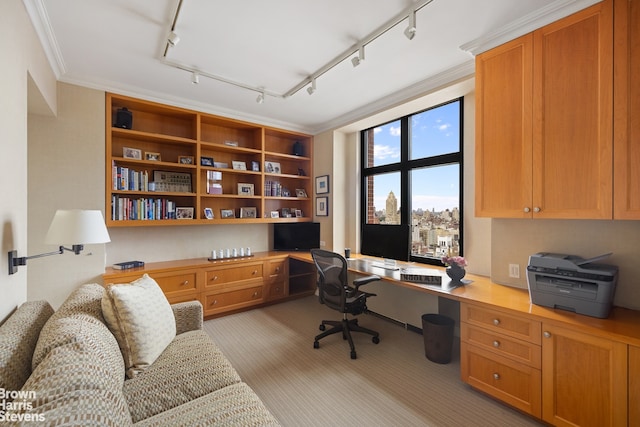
[360, 224, 409, 261]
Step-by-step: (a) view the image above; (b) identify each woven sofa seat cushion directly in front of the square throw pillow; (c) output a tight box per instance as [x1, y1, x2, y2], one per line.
[123, 331, 240, 422]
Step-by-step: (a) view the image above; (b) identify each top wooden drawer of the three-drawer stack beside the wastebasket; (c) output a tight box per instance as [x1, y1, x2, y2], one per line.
[460, 303, 542, 345]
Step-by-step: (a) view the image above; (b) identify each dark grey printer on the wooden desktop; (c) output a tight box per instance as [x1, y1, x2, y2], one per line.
[527, 252, 618, 318]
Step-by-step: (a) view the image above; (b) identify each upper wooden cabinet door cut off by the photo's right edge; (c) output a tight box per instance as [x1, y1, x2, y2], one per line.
[613, 0, 640, 219]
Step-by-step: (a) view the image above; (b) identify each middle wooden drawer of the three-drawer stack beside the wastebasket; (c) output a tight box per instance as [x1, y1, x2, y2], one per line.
[460, 322, 542, 369]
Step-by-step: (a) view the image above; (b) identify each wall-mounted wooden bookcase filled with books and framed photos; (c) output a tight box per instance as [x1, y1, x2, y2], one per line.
[106, 93, 313, 227]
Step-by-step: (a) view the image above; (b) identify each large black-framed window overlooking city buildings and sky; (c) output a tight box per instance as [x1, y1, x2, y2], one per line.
[361, 98, 463, 264]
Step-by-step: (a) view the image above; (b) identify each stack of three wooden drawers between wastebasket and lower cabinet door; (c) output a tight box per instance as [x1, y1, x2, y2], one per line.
[460, 303, 541, 417]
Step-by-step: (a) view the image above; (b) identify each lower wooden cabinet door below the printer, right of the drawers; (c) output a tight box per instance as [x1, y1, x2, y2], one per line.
[542, 324, 627, 427]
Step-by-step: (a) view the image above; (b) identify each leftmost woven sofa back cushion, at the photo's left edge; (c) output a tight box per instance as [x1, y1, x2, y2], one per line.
[0, 301, 53, 400]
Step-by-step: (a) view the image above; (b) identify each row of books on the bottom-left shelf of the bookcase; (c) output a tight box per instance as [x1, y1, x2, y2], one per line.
[111, 194, 176, 221]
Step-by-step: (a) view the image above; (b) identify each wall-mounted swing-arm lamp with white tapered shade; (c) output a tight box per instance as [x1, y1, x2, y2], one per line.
[8, 210, 111, 274]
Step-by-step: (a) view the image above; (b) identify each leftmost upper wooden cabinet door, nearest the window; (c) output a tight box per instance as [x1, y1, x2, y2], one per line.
[475, 34, 533, 218]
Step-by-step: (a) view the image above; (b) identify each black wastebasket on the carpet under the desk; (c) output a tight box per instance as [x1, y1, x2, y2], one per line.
[422, 314, 456, 364]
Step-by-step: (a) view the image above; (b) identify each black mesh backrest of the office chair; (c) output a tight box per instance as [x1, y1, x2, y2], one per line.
[311, 249, 348, 312]
